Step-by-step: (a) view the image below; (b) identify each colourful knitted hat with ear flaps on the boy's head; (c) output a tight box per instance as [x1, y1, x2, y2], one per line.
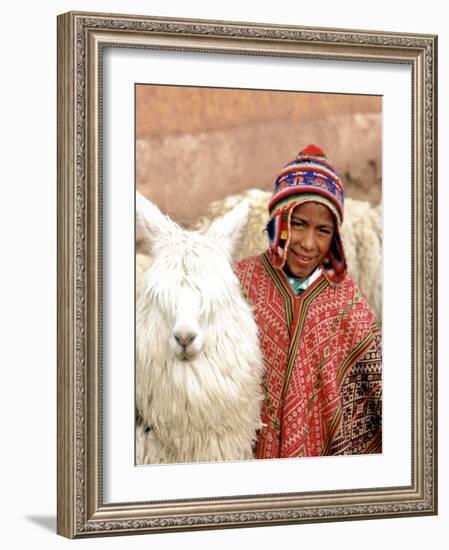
[267, 145, 347, 283]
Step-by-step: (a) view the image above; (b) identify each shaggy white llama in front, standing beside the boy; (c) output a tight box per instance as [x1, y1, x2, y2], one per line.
[136, 193, 263, 463]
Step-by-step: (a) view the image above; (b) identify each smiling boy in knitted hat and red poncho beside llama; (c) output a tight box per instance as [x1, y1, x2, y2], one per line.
[236, 145, 382, 458]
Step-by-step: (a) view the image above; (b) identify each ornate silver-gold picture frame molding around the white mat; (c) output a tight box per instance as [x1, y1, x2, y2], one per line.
[57, 12, 437, 538]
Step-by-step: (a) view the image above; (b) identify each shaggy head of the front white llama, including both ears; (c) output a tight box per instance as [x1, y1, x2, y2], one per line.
[136, 193, 248, 361]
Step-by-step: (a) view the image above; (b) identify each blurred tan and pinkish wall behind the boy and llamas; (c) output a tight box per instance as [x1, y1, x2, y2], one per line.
[136, 85, 382, 225]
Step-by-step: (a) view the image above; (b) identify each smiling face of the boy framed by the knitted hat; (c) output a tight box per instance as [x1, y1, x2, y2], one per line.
[286, 202, 335, 279]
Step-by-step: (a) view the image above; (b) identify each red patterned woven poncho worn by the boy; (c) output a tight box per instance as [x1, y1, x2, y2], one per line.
[235, 253, 382, 458]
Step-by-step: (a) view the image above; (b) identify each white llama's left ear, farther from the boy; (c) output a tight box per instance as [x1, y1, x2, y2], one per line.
[136, 191, 177, 246]
